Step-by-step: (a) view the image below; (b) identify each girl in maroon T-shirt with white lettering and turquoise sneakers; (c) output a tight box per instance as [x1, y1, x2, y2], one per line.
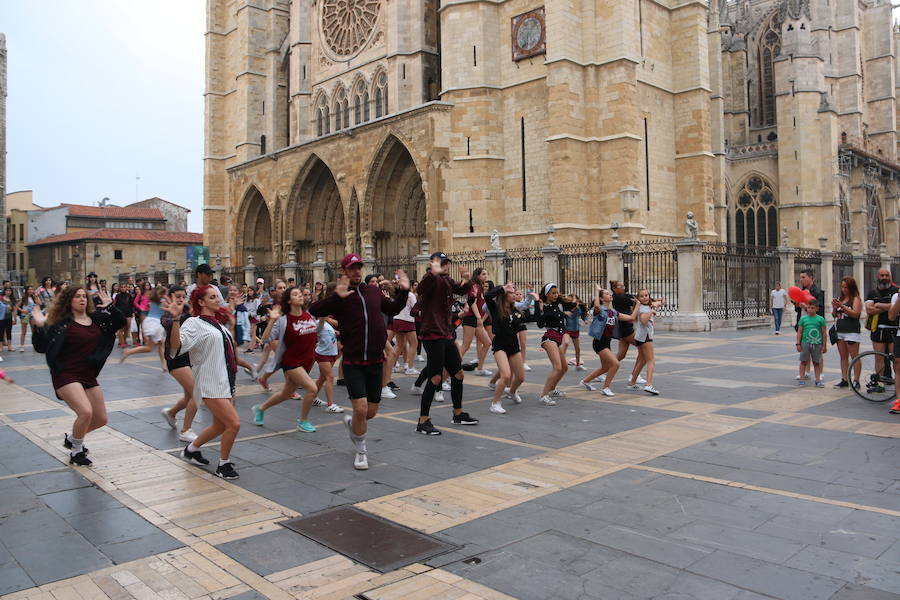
[252, 287, 318, 433]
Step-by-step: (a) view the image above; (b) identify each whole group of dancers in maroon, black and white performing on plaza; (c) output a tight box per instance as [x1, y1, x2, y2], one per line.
[24, 252, 661, 479]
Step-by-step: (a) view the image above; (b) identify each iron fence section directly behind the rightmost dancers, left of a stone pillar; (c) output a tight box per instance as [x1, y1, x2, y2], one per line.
[622, 241, 678, 315]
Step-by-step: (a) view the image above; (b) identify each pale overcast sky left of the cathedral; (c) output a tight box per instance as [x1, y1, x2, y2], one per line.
[0, 0, 206, 231]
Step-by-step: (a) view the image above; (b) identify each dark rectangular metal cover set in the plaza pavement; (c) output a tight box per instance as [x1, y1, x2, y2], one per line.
[280, 506, 459, 573]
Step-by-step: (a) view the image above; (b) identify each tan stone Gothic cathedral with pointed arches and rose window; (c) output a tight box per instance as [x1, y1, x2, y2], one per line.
[204, 0, 900, 265]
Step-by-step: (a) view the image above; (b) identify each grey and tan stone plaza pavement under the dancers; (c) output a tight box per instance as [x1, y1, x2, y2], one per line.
[0, 330, 900, 600]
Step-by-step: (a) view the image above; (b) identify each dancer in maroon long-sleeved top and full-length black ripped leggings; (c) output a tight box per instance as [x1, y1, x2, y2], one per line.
[416, 252, 478, 435]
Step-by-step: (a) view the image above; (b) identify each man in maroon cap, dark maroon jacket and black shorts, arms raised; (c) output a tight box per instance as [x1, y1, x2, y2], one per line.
[309, 254, 409, 469]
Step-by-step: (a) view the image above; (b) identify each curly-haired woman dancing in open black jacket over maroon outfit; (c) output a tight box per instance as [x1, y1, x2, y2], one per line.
[31, 286, 125, 466]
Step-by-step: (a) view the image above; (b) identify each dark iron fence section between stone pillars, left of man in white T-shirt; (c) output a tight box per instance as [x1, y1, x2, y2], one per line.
[703, 242, 781, 319]
